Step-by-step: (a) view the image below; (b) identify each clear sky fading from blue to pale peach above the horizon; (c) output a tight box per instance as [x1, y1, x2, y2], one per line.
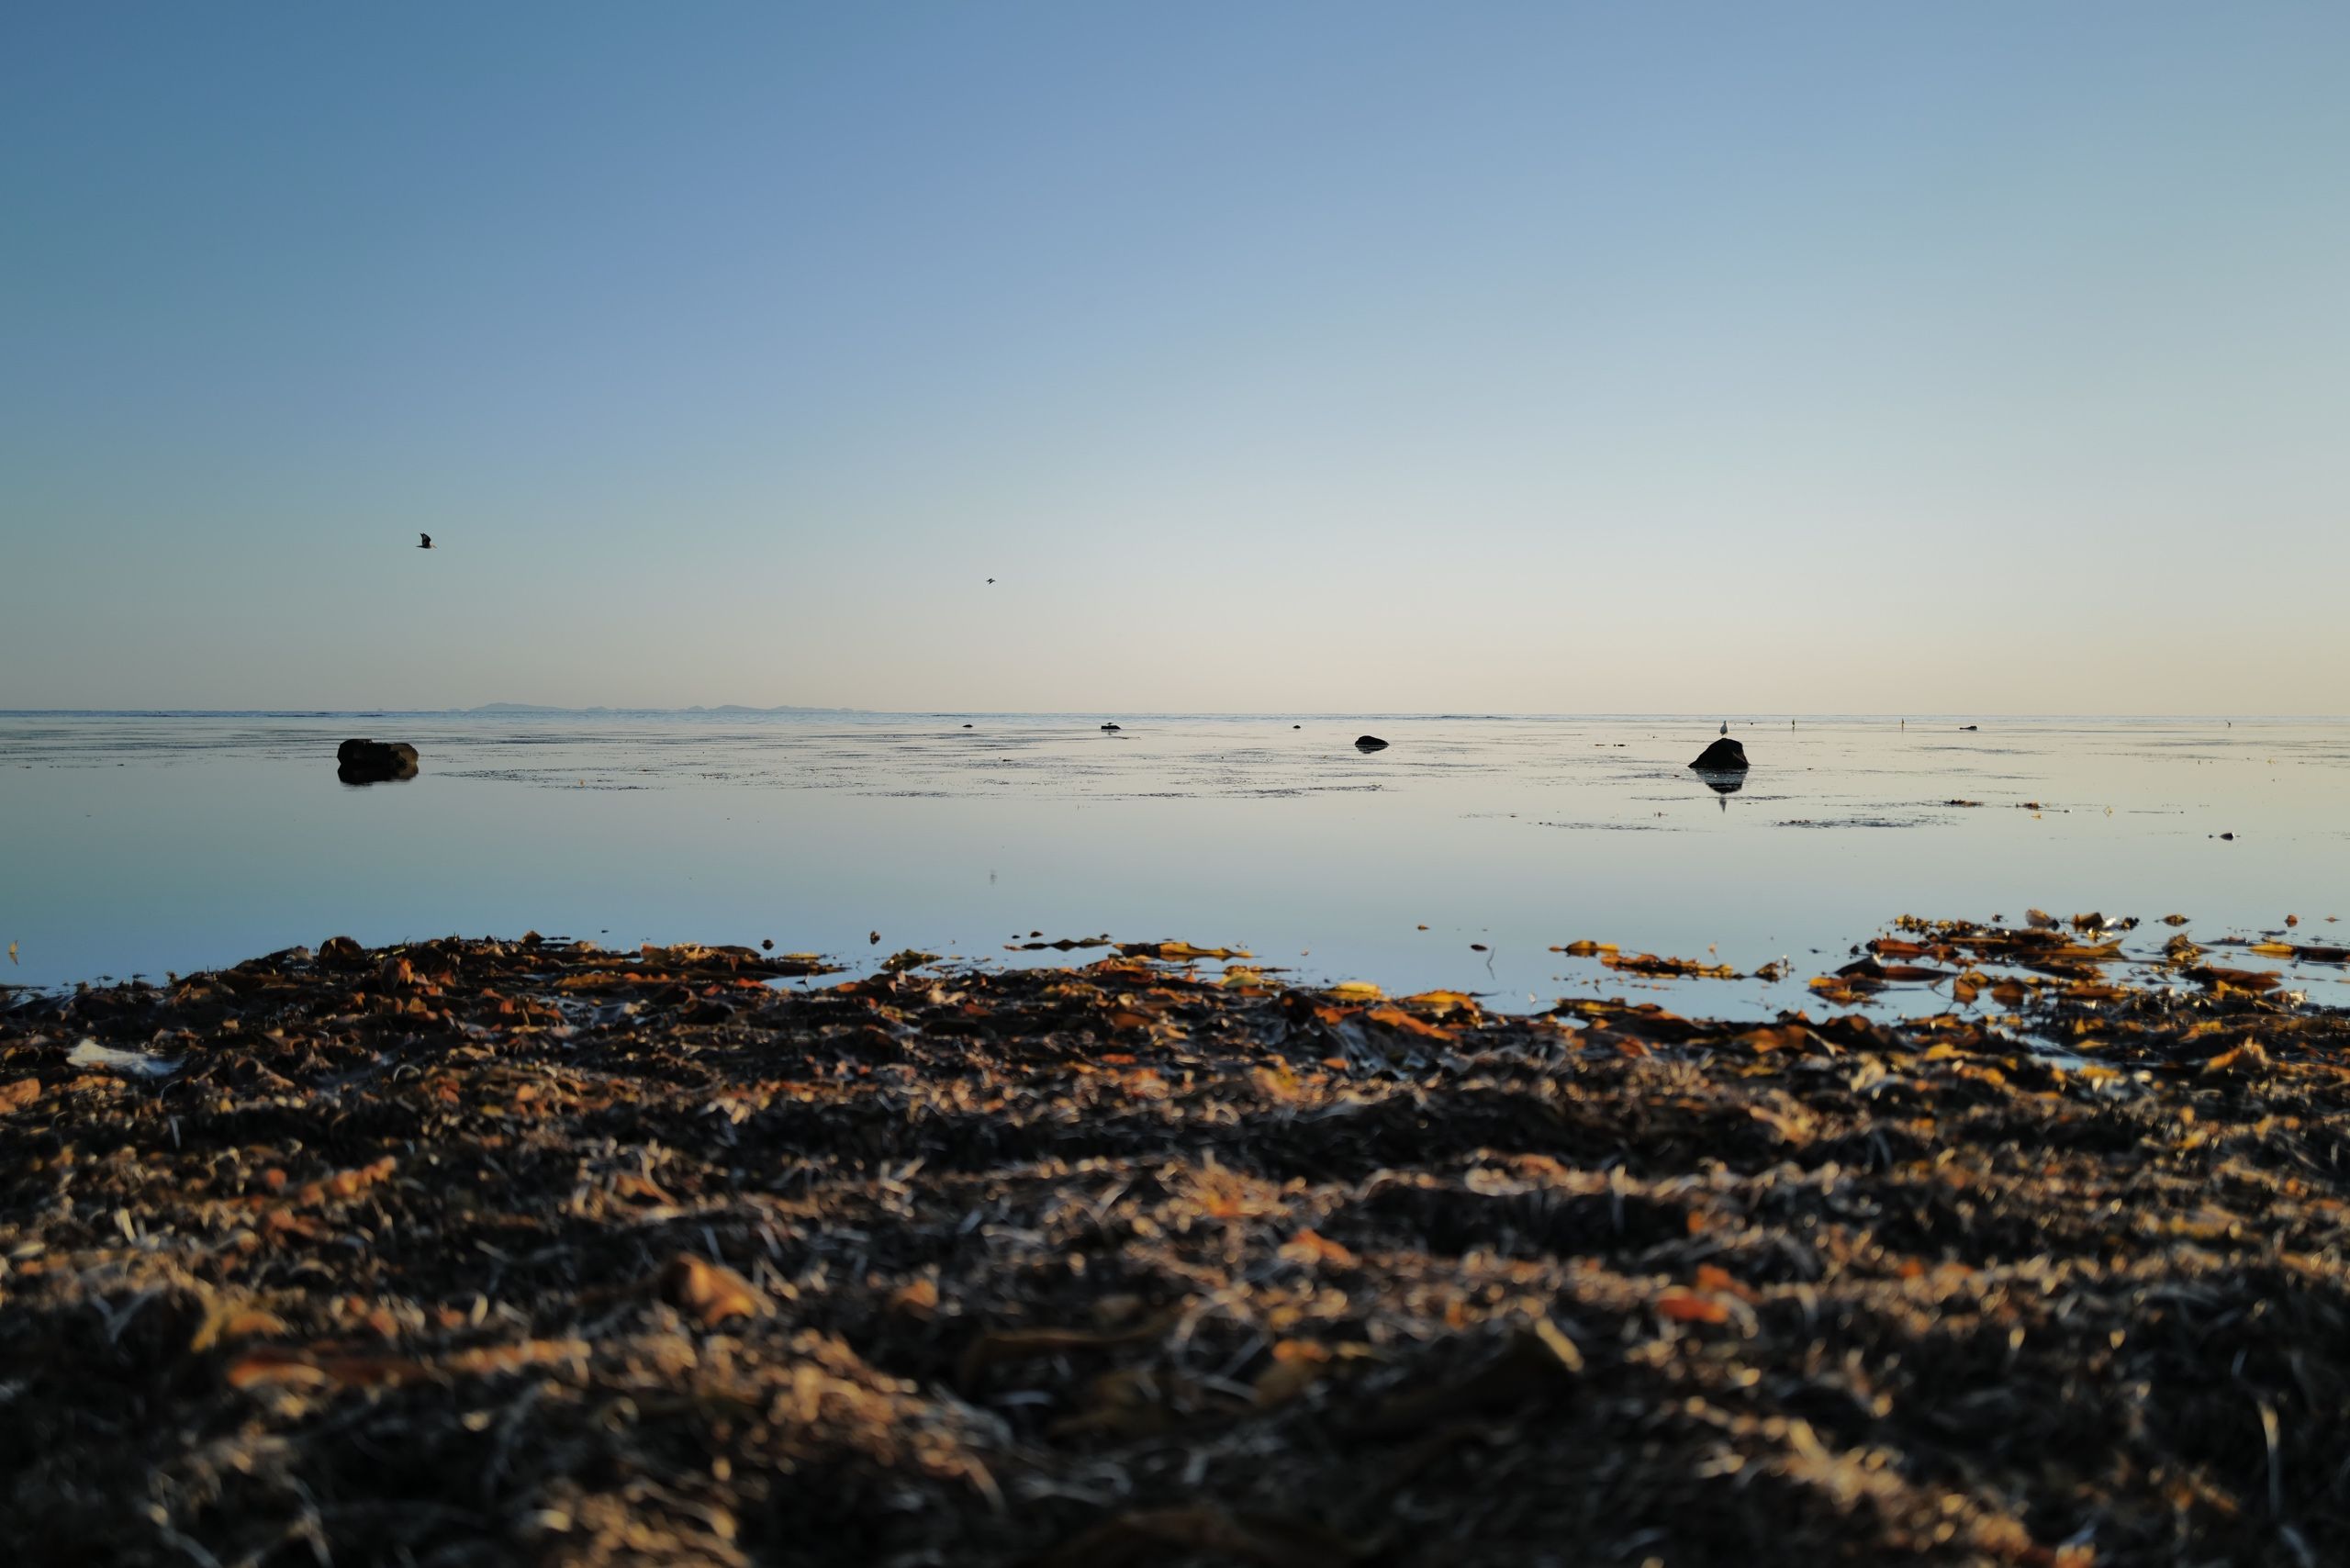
[0, 0, 2350, 714]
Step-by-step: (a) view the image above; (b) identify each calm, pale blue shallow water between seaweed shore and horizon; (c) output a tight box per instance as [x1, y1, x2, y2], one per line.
[0, 712, 2350, 1014]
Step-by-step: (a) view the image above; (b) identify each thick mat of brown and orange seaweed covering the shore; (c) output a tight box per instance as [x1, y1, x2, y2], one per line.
[0, 926, 2350, 1568]
